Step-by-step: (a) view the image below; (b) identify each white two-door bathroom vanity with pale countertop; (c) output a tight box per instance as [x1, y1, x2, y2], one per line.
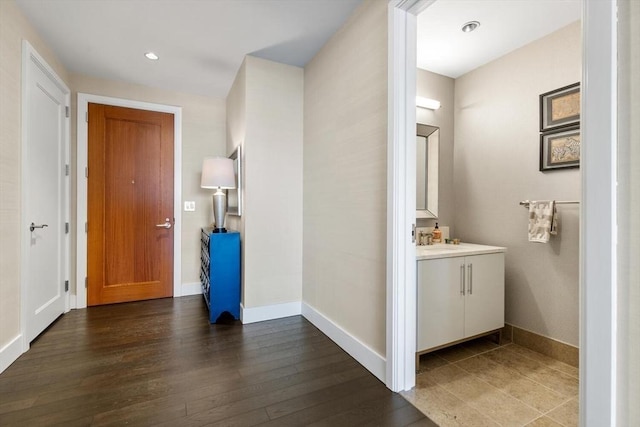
[416, 243, 506, 353]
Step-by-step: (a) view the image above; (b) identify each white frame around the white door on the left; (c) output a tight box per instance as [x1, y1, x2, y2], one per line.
[20, 40, 71, 353]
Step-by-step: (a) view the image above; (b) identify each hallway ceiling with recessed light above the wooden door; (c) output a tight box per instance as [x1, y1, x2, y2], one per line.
[15, 0, 362, 98]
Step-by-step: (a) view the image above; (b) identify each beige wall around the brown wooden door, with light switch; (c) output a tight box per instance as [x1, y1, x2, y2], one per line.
[71, 74, 227, 294]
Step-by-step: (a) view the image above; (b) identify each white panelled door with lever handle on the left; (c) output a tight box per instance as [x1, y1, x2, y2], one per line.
[22, 42, 69, 345]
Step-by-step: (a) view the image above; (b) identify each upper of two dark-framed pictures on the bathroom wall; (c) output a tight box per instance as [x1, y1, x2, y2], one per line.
[540, 83, 580, 132]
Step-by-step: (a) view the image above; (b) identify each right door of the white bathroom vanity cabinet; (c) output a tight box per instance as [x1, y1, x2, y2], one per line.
[464, 253, 504, 337]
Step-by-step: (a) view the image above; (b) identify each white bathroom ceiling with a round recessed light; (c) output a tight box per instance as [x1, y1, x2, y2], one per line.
[417, 0, 582, 78]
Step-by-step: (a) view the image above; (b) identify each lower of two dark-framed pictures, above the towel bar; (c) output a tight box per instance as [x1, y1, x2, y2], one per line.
[540, 126, 580, 172]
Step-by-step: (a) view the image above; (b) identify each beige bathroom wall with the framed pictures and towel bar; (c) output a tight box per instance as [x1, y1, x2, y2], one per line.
[454, 22, 582, 346]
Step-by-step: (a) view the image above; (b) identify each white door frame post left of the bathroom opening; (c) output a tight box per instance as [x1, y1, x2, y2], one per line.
[386, 0, 435, 391]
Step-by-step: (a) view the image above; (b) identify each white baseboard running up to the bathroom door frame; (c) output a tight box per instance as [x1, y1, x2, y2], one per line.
[302, 302, 387, 384]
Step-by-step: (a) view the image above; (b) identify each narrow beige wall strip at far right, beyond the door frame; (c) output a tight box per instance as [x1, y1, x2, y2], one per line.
[616, 1, 640, 426]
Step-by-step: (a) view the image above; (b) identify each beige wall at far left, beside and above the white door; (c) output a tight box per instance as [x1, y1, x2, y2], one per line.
[0, 0, 69, 349]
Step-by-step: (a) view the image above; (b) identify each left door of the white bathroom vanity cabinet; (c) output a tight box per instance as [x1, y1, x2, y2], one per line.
[417, 257, 464, 351]
